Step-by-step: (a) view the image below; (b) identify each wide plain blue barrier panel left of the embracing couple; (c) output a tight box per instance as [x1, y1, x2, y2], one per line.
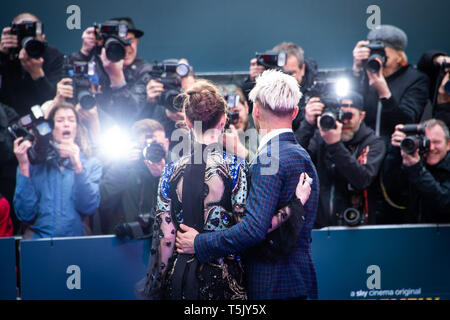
[20, 235, 150, 300]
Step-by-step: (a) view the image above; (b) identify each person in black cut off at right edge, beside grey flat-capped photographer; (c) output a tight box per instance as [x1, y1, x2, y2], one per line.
[417, 50, 450, 127]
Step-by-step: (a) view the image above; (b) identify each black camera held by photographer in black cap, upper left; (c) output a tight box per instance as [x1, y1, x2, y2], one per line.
[94, 21, 130, 62]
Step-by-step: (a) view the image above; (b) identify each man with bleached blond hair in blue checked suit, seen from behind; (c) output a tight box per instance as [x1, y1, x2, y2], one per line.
[176, 70, 319, 299]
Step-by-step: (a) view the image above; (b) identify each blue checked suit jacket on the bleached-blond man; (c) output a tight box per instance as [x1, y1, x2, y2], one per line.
[194, 132, 319, 299]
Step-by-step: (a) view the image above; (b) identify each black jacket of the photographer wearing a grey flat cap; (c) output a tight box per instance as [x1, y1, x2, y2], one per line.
[354, 65, 428, 145]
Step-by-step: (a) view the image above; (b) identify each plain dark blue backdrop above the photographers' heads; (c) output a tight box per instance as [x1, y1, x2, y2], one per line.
[0, 0, 450, 72]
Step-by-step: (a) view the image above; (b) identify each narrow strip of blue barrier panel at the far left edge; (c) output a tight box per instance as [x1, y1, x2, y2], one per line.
[0, 237, 17, 300]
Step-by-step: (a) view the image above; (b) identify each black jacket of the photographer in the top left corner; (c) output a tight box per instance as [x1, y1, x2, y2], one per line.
[0, 46, 64, 116]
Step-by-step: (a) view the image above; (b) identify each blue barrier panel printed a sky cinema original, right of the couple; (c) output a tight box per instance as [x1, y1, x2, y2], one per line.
[312, 225, 450, 300]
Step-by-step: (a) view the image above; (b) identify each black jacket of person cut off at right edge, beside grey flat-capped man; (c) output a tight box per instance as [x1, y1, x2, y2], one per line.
[417, 50, 450, 127]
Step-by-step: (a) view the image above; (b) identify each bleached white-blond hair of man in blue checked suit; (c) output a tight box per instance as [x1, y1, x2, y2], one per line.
[249, 69, 302, 114]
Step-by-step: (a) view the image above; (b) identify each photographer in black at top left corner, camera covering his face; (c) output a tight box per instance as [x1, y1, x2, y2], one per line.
[0, 13, 63, 116]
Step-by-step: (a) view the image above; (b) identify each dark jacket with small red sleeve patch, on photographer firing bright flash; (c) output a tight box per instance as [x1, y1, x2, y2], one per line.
[296, 120, 386, 228]
